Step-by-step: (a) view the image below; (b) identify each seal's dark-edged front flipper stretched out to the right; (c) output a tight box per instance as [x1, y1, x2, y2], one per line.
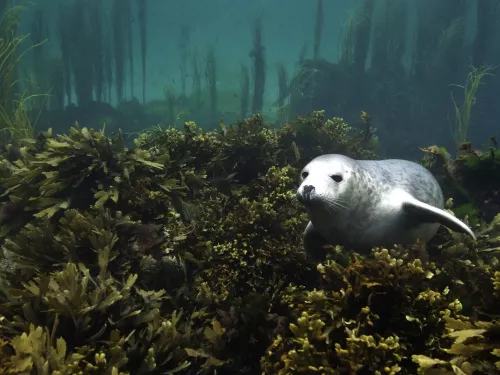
[402, 192, 476, 240]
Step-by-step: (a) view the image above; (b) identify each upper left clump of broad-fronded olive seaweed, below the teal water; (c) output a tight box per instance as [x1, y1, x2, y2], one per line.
[0, 125, 206, 236]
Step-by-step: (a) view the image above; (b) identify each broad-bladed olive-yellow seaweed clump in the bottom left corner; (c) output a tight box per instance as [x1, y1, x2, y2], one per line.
[2, 263, 221, 374]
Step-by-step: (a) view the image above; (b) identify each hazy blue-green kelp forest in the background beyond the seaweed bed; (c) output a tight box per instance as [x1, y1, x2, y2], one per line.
[3, 0, 500, 157]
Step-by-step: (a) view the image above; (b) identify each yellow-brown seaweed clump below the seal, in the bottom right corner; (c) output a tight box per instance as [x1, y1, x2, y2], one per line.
[261, 207, 500, 374]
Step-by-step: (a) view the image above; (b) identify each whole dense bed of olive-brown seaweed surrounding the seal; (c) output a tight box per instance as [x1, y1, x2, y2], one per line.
[0, 112, 500, 374]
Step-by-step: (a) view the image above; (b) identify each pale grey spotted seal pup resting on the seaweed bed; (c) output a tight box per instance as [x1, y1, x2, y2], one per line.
[296, 154, 476, 261]
